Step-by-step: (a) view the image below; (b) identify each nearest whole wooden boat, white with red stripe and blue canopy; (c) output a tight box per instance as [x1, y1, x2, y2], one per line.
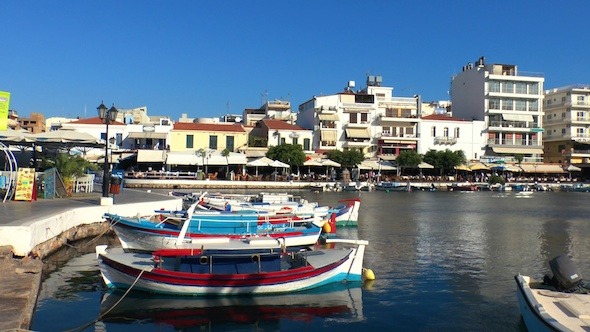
[96, 239, 372, 296]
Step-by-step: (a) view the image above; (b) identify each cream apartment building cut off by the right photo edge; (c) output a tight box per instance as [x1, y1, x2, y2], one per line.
[543, 85, 590, 165]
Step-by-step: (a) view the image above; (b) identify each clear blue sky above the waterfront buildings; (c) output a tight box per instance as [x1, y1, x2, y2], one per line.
[0, 0, 590, 119]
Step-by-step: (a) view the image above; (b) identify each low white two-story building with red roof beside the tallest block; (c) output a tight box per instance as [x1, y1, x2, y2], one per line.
[418, 114, 487, 160]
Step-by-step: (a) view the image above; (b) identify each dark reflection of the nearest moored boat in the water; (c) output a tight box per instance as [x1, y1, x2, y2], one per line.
[100, 283, 363, 330]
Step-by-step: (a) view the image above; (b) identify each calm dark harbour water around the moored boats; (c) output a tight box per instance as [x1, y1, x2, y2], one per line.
[31, 191, 590, 331]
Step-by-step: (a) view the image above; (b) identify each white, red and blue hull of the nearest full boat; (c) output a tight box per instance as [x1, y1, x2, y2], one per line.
[97, 241, 366, 296]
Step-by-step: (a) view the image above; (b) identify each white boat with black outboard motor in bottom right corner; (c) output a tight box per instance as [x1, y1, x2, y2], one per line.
[514, 255, 590, 331]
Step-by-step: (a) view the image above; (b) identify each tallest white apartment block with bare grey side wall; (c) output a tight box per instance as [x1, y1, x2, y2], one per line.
[451, 57, 544, 162]
